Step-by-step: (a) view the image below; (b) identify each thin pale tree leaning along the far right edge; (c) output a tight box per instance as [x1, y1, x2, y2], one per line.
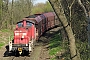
[77, 0, 90, 60]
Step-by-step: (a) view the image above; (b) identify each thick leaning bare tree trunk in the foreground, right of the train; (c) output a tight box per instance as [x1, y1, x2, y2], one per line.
[49, 0, 80, 60]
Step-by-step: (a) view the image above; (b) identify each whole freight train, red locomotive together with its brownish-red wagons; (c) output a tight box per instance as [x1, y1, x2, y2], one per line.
[9, 12, 55, 55]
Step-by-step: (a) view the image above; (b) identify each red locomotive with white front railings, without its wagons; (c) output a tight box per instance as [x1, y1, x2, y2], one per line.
[9, 20, 35, 54]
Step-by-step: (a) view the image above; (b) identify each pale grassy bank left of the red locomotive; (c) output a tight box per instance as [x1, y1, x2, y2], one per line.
[0, 29, 13, 48]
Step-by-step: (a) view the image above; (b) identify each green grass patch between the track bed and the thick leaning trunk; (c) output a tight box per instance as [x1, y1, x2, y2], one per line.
[49, 34, 62, 60]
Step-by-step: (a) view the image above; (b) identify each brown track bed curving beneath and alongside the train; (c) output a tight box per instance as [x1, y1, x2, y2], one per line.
[0, 27, 60, 60]
